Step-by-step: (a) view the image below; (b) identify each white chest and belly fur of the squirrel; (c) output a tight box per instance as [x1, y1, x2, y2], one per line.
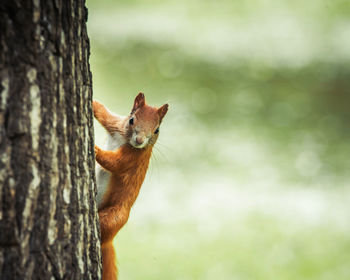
[96, 130, 125, 207]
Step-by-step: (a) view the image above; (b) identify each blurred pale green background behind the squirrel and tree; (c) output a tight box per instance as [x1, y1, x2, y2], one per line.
[87, 0, 350, 280]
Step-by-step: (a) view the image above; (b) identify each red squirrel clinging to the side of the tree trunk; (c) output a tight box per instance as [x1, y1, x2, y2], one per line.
[93, 93, 168, 280]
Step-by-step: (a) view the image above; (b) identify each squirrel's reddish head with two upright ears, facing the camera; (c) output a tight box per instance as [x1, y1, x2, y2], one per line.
[126, 92, 169, 149]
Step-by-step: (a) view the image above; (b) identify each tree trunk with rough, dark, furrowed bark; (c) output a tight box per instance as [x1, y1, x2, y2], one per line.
[0, 0, 101, 280]
